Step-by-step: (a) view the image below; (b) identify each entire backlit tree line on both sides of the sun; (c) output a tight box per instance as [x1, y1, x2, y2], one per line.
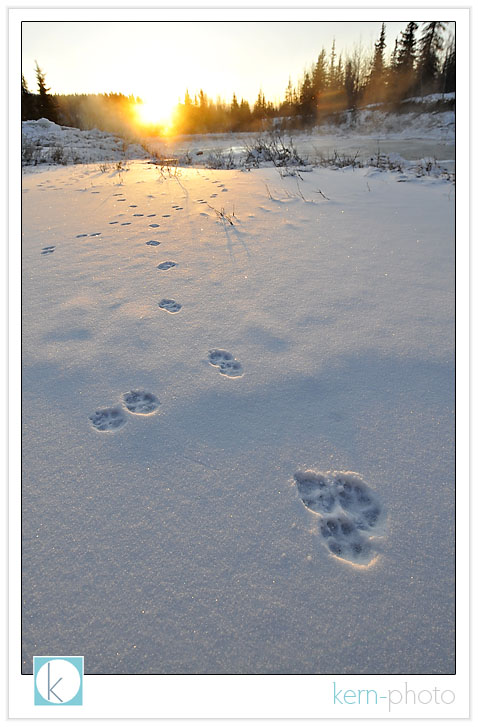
[22, 22, 456, 134]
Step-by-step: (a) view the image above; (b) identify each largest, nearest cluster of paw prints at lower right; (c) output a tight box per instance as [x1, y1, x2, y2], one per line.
[294, 470, 383, 565]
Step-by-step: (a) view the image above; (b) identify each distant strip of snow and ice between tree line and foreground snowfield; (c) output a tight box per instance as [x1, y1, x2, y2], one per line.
[22, 102, 455, 172]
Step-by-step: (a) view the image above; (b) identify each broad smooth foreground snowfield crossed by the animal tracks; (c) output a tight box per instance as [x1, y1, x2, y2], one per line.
[22, 154, 454, 674]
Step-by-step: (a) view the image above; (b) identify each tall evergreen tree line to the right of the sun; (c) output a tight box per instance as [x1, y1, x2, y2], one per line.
[175, 22, 455, 133]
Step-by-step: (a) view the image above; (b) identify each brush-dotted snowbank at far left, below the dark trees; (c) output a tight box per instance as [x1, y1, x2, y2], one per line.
[22, 119, 148, 165]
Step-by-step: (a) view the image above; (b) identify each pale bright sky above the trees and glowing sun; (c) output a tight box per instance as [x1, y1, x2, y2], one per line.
[22, 22, 406, 123]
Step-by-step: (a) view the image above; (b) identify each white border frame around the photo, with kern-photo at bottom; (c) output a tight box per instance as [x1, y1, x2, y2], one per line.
[9, 3, 470, 719]
